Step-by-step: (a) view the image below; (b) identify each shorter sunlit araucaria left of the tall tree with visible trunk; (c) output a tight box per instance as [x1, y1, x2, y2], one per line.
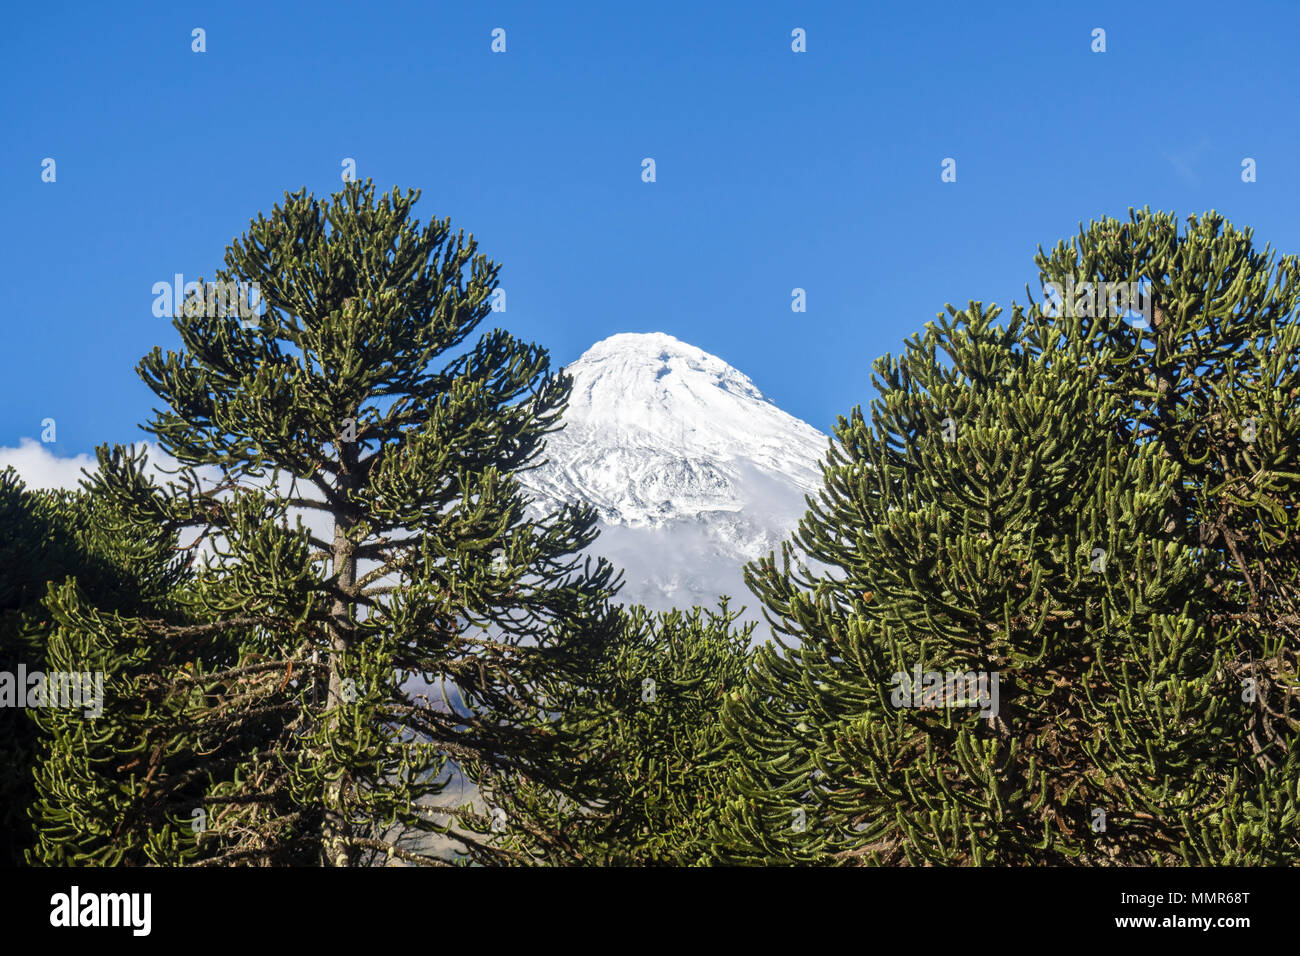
[30, 449, 253, 865]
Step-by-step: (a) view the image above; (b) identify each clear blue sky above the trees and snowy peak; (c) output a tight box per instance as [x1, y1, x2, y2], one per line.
[0, 0, 1300, 455]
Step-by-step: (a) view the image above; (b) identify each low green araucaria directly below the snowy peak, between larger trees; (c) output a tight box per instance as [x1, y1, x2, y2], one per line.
[478, 598, 754, 866]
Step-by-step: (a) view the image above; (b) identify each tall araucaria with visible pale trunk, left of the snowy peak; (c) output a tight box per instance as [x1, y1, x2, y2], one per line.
[30, 183, 611, 865]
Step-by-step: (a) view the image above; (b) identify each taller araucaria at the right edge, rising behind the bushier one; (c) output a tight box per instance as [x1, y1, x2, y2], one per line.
[1031, 211, 1300, 766]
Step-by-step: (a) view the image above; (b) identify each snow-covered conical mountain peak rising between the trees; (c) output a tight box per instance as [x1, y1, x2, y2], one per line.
[520, 332, 827, 620]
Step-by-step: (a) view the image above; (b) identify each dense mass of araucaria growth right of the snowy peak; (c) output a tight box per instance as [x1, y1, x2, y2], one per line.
[725, 211, 1300, 865]
